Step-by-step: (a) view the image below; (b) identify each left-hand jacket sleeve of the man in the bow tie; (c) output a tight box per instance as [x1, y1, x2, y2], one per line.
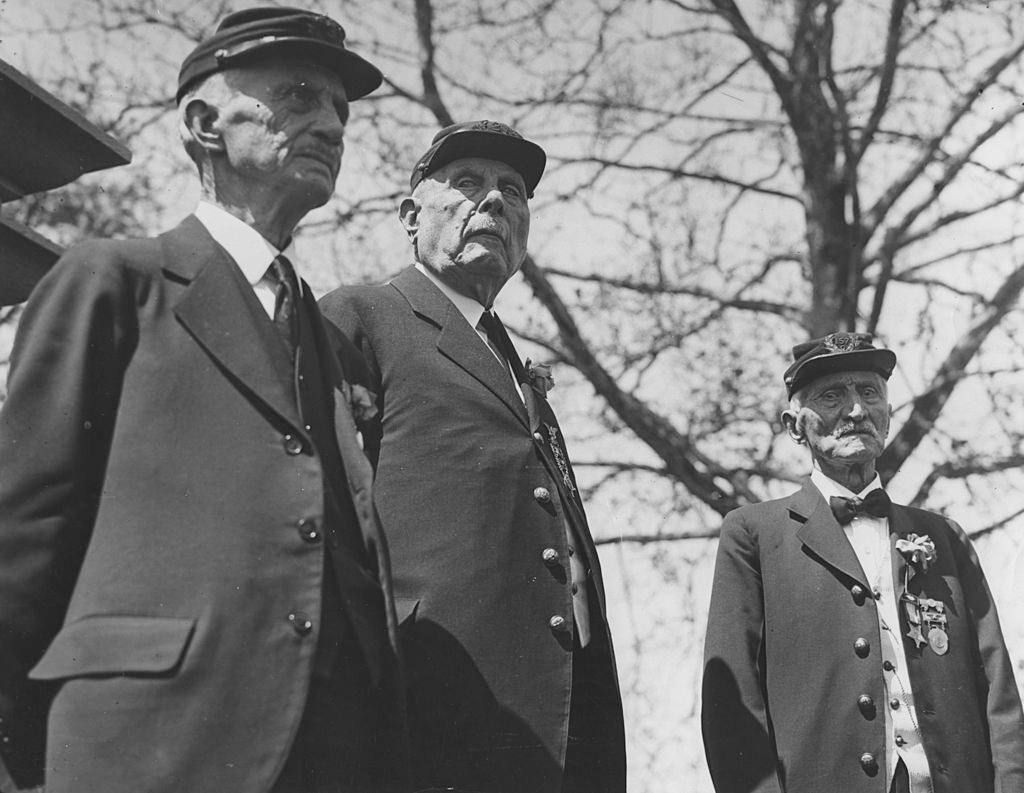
[700, 511, 781, 793]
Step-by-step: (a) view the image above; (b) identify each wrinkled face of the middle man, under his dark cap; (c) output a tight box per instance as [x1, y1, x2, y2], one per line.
[401, 157, 529, 306]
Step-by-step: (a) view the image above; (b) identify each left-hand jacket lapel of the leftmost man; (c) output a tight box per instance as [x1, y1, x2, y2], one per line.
[161, 217, 301, 427]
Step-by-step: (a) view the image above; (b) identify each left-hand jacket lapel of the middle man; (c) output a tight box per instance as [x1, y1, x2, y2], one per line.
[391, 267, 529, 429]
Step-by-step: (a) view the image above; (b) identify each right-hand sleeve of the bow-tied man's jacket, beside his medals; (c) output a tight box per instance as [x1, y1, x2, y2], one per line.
[947, 520, 1024, 793]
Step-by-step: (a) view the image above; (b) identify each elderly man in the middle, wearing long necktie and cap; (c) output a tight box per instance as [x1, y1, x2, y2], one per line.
[322, 121, 625, 793]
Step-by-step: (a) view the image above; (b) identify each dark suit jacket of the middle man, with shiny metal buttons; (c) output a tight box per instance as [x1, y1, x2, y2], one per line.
[321, 267, 625, 793]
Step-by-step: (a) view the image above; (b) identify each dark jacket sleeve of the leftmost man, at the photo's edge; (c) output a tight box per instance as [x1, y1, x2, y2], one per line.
[0, 244, 131, 786]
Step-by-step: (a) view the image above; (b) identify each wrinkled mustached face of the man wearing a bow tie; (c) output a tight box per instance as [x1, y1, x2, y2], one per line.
[787, 372, 892, 466]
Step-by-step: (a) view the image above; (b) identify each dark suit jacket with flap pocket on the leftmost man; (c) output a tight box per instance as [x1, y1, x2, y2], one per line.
[0, 218, 401, 793]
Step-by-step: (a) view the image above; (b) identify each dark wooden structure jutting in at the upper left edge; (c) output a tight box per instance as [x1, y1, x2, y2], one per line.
[0, 60, 131, 305]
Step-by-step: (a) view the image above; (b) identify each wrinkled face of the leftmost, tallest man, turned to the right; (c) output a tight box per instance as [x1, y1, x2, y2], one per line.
[217, 57, 348, 209]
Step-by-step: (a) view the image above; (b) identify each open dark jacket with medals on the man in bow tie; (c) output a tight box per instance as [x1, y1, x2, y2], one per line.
[701, 481, 1024, 793]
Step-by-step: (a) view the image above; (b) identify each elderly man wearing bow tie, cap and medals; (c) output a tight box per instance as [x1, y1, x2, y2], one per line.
[701, 333, 1024, 793]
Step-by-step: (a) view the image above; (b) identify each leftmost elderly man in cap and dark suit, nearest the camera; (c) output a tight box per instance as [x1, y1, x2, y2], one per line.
[0, 8, 409, 793]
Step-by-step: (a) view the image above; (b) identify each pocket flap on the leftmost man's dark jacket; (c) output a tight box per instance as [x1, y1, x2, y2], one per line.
[29, 615, 195, 680]
